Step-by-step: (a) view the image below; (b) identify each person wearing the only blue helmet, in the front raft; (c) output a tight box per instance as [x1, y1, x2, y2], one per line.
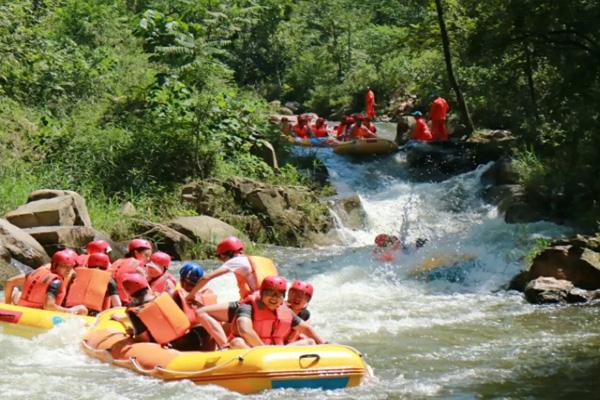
[168, 262, 217, 351]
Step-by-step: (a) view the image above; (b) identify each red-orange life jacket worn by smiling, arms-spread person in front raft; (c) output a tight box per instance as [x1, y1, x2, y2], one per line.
[238, 295, 294, 345]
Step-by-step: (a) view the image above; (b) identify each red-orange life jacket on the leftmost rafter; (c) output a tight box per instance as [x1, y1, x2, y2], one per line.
[17, 267, 68, 310]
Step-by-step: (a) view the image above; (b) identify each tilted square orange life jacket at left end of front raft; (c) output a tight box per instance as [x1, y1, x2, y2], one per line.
[134, 293, 191, 345]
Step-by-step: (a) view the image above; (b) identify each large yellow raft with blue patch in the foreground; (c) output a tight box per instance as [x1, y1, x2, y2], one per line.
[81, 309, 371, 394]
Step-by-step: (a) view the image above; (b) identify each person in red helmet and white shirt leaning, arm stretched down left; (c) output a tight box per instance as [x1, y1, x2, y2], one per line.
[188, 236, 278, 301]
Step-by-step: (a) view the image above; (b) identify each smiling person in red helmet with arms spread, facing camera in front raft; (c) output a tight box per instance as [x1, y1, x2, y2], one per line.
[230, 276, 325, 348]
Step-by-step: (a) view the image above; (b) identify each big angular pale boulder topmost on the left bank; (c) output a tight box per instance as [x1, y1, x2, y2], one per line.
[6, 190, 92, 228]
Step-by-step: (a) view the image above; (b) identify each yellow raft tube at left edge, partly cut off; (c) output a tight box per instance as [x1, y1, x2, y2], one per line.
[0, 303, 96, 337]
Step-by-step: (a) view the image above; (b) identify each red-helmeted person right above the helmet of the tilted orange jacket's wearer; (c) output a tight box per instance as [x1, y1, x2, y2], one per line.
[111, 239, 152, 305]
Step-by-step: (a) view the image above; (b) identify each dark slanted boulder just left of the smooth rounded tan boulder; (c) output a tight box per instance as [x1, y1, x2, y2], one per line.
[134, 220, 193, 260]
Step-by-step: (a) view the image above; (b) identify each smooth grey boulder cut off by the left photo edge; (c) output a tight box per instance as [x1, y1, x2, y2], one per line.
[0, 218, 50, 268]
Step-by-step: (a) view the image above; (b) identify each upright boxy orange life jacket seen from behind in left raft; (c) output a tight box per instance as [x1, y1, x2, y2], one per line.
[65, 267, 112, 311]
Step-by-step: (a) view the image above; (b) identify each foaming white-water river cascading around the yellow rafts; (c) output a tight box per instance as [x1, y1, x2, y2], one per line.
[0, 125, 600, 399]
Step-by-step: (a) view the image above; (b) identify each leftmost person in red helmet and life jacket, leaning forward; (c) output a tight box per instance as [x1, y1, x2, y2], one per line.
[4, 250, 88, 315]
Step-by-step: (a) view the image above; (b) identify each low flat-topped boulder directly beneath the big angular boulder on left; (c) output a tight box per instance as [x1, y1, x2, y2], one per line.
[23, 226, 98, 254]
